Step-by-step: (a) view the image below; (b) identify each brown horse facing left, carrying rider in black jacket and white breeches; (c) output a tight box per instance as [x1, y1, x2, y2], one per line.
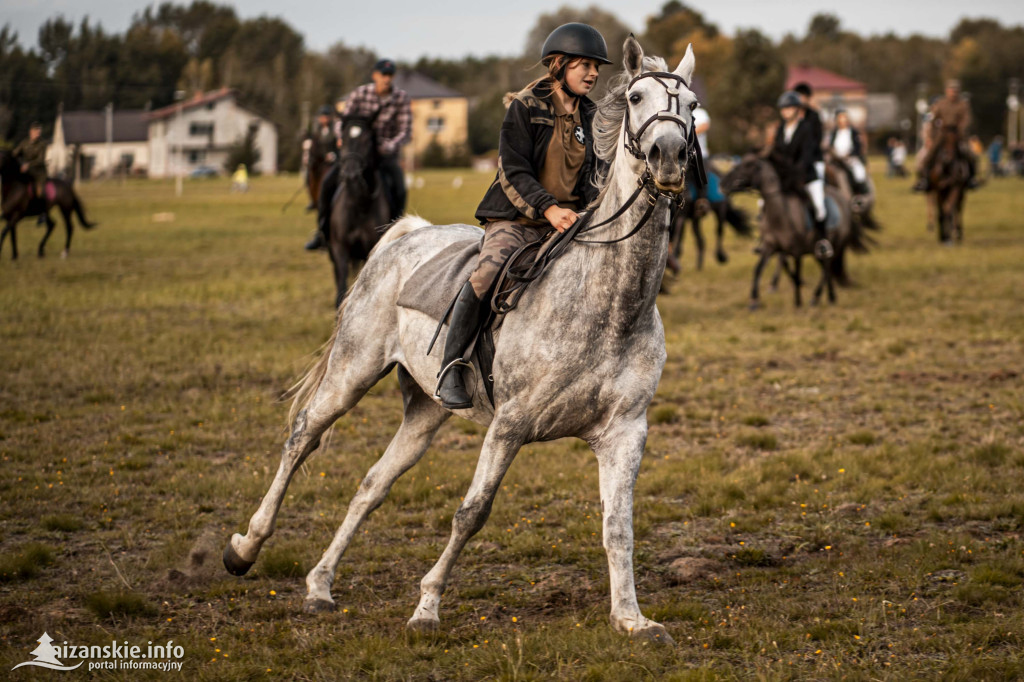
[722, 155, 866, 309]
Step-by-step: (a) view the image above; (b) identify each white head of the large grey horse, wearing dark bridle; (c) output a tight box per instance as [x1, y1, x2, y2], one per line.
[623, 36, 697, 194]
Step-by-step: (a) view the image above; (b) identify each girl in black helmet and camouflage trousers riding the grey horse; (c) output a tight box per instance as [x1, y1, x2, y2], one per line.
[437, 24, 611, 410]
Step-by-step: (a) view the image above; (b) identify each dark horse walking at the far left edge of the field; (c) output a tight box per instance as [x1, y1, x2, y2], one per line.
[0, 151, 95, 260]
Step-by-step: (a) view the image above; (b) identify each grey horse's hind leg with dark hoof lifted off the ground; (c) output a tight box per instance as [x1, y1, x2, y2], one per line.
[223, 331, 389, 576]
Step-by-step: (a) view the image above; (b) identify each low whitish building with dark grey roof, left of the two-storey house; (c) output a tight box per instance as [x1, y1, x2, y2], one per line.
[46, 110, 150, 178]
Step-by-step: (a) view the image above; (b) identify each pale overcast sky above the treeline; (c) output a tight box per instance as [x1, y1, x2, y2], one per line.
[6, 0, 1024, 59]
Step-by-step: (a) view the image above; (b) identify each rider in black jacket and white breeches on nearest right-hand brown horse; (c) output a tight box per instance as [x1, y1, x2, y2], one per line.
[772, 90, 833, 258]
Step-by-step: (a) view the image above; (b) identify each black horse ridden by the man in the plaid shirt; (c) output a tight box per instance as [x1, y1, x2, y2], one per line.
[328, 117, 391, 305]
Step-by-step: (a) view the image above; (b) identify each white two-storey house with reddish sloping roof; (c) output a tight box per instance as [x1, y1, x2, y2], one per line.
[146, 88, 278, 177]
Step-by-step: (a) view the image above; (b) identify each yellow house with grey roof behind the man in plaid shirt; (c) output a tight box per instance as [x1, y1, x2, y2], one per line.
[394, 71, 469, 168]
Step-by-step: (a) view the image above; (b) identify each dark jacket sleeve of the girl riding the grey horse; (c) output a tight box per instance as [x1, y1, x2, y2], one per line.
[498, 99, 558, 220]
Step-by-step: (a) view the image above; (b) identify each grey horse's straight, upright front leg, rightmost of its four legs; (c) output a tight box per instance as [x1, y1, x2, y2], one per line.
[591, 414, 675, 644]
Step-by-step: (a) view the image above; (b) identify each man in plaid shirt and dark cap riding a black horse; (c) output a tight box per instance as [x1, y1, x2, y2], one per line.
[306, 59, 413, 251]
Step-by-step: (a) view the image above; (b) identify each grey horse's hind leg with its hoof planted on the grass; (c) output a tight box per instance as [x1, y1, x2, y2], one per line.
[303, 366, 452, 613]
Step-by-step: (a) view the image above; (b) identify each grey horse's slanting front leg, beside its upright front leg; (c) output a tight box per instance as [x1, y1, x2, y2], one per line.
[407, 415, 522, 631]
